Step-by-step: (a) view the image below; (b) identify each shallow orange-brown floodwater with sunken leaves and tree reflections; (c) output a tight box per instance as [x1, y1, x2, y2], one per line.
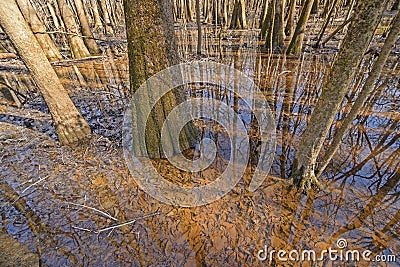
[0, 31, 400, 266]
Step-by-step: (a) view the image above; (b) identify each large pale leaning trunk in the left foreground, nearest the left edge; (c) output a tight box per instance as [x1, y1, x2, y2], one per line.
[0, 0, 90, 144]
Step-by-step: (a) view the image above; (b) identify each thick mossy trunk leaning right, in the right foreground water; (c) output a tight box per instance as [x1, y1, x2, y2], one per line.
[292, 0, 386, 190]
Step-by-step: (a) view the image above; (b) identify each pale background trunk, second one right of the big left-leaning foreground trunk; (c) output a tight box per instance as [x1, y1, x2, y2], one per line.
[57, 0, 90, 58]
